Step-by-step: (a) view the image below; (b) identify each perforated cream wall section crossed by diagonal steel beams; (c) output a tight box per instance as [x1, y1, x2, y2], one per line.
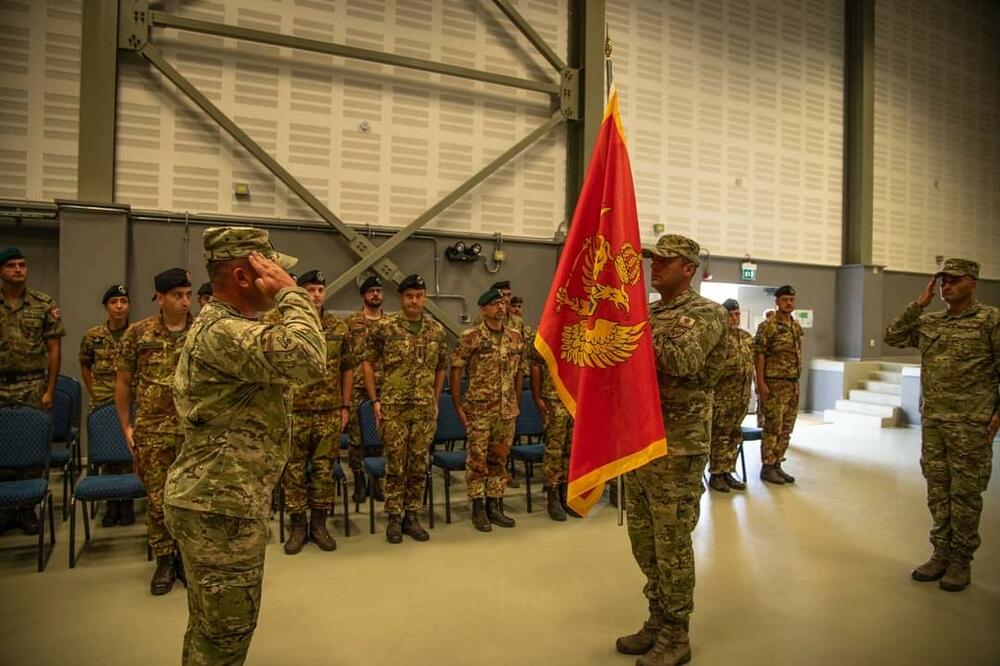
[116, 0, 567, 238]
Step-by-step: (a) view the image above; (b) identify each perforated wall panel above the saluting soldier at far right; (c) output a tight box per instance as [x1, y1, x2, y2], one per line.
[873, 0, 1000, 278]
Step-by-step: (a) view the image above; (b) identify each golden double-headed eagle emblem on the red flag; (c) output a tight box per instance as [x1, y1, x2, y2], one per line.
[555, 208, 646, 368]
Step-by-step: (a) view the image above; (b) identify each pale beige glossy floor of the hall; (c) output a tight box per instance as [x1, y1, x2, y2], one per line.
[0, 419, 1000, 666]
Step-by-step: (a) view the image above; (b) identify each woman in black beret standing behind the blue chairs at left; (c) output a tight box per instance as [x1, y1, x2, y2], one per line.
[80, 284, 135, 527]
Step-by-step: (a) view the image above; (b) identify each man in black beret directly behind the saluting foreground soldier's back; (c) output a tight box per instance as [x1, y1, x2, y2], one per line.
[115, 268, 192, 595]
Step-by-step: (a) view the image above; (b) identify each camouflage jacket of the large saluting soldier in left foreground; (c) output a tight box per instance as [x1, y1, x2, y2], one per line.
[165, 287, 326, 518]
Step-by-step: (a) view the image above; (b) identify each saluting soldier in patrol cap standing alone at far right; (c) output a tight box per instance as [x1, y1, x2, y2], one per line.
[885, 259, 1000, 592]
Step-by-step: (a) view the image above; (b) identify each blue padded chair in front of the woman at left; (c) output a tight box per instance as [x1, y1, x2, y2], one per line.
[69, 405, 151, 569]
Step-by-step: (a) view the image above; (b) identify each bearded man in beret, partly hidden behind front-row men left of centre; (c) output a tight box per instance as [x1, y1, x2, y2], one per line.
[344, 275, 385, 504]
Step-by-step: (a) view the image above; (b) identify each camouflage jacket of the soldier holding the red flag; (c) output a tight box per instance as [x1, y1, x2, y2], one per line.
[649, 289, 729, 456]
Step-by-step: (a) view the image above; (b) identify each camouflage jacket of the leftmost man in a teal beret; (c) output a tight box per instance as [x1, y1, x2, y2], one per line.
[0, 289, 66, 376]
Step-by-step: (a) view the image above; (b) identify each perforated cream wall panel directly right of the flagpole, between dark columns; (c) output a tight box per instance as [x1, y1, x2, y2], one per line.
[608, 0, 844, 264]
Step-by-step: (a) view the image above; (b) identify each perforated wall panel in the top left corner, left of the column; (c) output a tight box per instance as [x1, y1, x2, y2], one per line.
[0, 0, 82, 199]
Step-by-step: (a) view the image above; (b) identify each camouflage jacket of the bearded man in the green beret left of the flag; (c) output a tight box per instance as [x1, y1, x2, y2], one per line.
[451, 323, 525, 419]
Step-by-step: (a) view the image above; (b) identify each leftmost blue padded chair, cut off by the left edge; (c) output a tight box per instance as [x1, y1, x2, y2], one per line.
[0, 407, 56, 572]
